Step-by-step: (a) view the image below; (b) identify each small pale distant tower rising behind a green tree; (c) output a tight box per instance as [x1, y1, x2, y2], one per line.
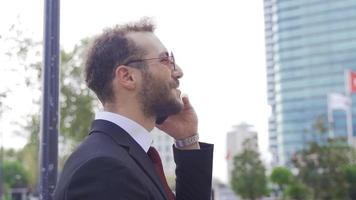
[226, 123, 258, 184]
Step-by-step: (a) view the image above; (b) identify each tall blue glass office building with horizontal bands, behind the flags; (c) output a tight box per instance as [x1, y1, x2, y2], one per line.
[264, 0, 356, 165]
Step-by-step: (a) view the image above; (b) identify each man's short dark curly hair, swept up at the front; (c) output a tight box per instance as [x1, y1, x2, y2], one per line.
[85, 18, 155, 103]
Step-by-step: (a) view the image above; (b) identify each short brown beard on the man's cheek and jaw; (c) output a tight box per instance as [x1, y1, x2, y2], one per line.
[139, 71, 183, 118]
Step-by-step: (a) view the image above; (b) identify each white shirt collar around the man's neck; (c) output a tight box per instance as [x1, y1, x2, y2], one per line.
[95, 111, 153, 153]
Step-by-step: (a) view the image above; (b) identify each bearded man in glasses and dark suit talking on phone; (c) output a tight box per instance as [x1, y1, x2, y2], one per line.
[54, 20, 213, 200]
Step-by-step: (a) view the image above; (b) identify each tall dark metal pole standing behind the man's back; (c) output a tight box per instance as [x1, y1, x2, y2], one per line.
[39, 0, 59, 200]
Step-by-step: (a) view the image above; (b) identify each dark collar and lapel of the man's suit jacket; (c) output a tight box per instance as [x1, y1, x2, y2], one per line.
[89, 120, 167, 199]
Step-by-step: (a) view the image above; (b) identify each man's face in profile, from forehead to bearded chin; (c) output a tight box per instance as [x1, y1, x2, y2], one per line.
[127, 33, 183, 117]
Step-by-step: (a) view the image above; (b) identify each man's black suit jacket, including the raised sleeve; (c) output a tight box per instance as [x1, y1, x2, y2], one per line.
[54, 120, 213, 200]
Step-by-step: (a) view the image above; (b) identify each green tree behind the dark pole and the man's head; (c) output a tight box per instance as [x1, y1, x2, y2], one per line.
[20, 41, 97, 186]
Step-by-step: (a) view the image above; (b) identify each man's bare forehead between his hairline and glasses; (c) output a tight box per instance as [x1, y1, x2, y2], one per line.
[127, 32, 167, 55]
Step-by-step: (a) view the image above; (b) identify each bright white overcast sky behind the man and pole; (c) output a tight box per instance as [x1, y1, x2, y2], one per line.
[0, 0, 269, 182]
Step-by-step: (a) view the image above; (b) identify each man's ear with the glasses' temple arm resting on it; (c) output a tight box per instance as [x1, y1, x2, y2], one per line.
[114, 65, 137, 90]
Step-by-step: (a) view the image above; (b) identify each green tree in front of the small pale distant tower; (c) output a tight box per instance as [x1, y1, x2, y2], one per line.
[231, 139, 268, 200]
